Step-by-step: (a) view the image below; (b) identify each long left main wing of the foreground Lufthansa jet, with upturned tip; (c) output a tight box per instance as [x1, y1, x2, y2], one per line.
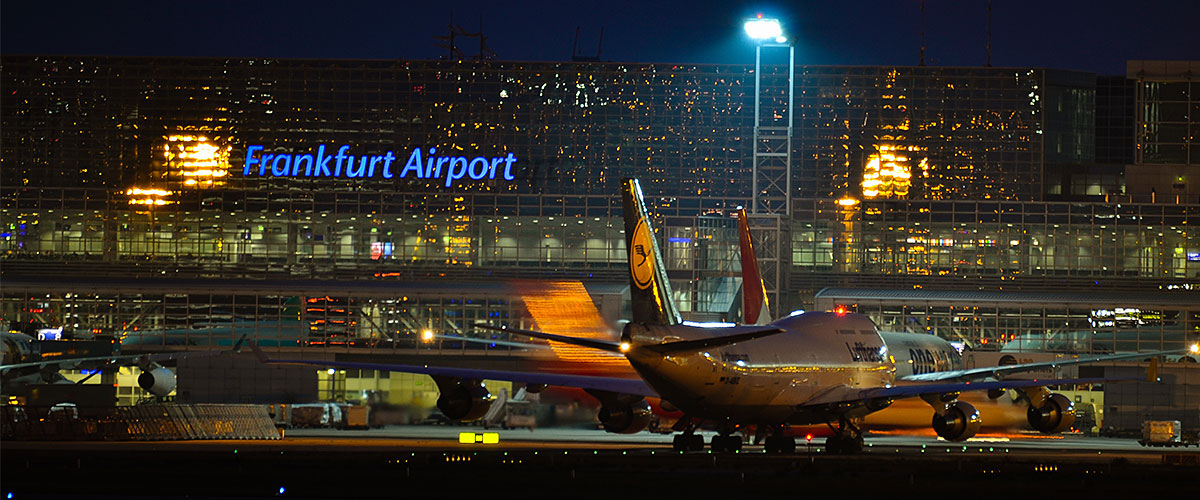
[250, 342, 659, 397]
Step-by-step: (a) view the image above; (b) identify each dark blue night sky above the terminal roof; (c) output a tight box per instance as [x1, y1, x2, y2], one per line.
[0, 0, 1200, 74]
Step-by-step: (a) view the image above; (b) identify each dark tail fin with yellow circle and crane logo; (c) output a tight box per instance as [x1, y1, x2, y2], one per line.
[620, 179, 682, 325]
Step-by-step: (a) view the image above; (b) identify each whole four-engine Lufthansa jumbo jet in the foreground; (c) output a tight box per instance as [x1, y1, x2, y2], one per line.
[250, 179, 1185, 453]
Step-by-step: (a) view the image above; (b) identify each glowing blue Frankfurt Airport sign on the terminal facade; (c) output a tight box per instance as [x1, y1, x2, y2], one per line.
[241, 144, 517, 187]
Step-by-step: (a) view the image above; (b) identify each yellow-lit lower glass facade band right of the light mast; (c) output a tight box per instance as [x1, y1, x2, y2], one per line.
[791, 200, 1200, 289]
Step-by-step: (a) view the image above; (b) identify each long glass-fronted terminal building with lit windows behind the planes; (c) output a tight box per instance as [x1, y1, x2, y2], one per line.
[0, 55, 1200, 424]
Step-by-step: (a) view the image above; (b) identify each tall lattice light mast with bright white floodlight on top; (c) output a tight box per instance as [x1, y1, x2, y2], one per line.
[745, 14, 796, 312]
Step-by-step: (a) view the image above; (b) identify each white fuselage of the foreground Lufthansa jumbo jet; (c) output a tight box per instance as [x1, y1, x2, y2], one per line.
[629, 313, 896, 424]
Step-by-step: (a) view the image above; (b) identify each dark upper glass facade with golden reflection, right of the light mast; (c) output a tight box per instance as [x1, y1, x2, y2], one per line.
[793, 67, 1046, 200]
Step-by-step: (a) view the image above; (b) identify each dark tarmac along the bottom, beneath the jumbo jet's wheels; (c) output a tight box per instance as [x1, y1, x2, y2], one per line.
[0, 426, 1200, 499]
